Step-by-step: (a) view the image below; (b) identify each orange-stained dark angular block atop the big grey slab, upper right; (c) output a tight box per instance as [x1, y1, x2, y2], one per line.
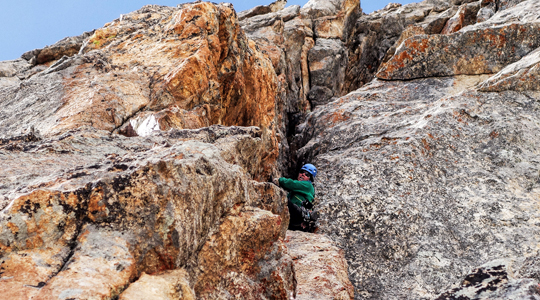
[376, 23, 540, 80]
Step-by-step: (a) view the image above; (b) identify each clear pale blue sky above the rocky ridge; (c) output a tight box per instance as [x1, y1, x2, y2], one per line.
[0, 0, 420, 61]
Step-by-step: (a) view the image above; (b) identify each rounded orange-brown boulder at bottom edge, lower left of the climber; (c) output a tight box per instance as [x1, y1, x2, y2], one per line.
[195, 208, 295, 299]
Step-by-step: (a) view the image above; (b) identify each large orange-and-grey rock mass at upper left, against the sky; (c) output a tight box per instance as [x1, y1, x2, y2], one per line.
[0, 3, 279, 180]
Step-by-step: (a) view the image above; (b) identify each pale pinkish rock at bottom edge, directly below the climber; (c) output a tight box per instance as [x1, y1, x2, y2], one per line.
[285, 231, 354, 300]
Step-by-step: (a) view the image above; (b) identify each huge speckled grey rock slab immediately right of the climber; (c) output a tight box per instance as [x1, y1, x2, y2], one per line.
[299, 76, 540, 299]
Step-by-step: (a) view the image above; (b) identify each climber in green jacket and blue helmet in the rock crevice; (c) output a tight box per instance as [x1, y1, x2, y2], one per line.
[274, 164, 319, 231]
